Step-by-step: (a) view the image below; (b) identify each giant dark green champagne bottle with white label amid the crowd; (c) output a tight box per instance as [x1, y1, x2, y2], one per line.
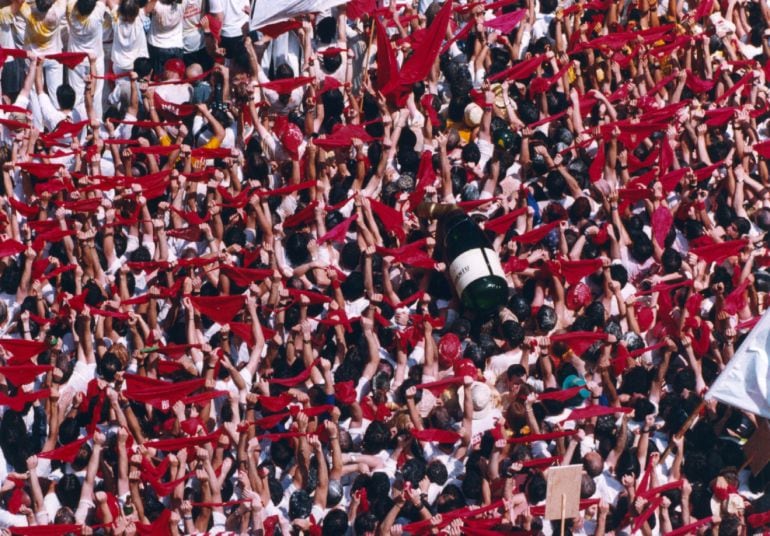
[415, 203, 508, 314]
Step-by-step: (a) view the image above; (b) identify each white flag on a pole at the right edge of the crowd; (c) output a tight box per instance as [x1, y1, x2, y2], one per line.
[706, 311, 770, 418]
